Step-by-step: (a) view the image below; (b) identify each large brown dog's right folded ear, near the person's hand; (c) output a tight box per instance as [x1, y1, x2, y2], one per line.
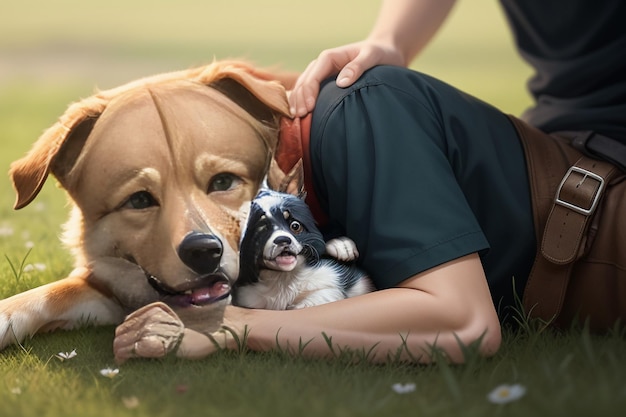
[198, 61, 295, 122]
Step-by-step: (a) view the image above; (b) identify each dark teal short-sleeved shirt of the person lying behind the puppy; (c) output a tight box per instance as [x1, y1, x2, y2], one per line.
[310, 67, 535, 312]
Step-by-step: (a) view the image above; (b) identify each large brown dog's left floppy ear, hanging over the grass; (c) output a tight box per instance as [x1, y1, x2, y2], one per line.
[9, 97, 104, 210]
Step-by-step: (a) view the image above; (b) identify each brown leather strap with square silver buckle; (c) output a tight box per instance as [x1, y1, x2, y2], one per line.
[509, 116, 618, 324]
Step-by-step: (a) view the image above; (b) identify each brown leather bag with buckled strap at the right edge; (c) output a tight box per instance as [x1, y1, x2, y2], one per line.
[510, 117, 626, 331]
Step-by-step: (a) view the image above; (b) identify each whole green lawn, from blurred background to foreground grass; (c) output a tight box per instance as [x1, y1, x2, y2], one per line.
[0, 0, 626, 417]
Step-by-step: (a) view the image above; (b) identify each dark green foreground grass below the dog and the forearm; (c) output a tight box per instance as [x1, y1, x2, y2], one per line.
[0, 322, 626, 416]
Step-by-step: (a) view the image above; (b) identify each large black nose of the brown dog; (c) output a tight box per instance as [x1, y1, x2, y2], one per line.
[178, 232, 224, 274]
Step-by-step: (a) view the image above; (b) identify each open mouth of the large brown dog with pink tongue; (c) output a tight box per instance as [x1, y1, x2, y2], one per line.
[146, 273, 230, 307]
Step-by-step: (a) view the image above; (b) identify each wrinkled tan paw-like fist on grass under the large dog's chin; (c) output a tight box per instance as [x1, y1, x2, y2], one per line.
[113, 302, 185, 363]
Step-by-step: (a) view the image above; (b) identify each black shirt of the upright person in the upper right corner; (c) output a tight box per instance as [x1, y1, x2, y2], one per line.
[501, 0, 626, 142]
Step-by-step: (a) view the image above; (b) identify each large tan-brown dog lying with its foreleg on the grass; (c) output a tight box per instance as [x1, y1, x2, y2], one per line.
[0, 61, 292, 348]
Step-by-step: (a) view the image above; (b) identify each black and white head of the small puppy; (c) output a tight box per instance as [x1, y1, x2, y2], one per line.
[237, 189, 325, 286]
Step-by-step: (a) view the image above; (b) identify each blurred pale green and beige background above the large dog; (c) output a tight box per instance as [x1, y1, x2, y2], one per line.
[0, 0, 528, 103]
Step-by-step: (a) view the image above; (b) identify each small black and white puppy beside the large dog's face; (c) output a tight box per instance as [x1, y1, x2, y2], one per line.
[233, 190, 374, 310]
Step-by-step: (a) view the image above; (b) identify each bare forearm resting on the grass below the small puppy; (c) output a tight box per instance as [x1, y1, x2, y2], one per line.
[226, 255, 500, 363]
